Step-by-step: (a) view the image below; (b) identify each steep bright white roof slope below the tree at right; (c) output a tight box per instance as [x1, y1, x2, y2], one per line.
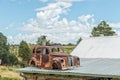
[71, 36, 120, 58]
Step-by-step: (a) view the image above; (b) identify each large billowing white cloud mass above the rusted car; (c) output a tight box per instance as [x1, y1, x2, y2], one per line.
[8, 0, 94, 43]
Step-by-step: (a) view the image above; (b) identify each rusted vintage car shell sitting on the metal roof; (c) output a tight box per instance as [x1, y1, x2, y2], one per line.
[29, 45, 80, 70]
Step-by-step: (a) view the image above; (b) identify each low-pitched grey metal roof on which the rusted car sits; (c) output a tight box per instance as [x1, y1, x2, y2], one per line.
[17, 58, 120, 78]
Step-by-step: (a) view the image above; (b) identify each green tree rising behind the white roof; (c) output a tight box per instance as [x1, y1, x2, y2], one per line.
[91, 21, 116, 37]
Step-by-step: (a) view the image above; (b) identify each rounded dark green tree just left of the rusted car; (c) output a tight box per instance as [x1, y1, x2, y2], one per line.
[18, 41, 31, 62]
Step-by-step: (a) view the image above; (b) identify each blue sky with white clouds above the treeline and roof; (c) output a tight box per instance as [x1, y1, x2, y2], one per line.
[0, 0, 120, 44]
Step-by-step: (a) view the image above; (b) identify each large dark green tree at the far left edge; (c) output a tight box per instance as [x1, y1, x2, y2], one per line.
[0, 33, 18, 65]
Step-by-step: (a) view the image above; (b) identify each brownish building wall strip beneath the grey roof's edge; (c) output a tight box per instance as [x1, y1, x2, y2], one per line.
[24, 73, 120, 80]
